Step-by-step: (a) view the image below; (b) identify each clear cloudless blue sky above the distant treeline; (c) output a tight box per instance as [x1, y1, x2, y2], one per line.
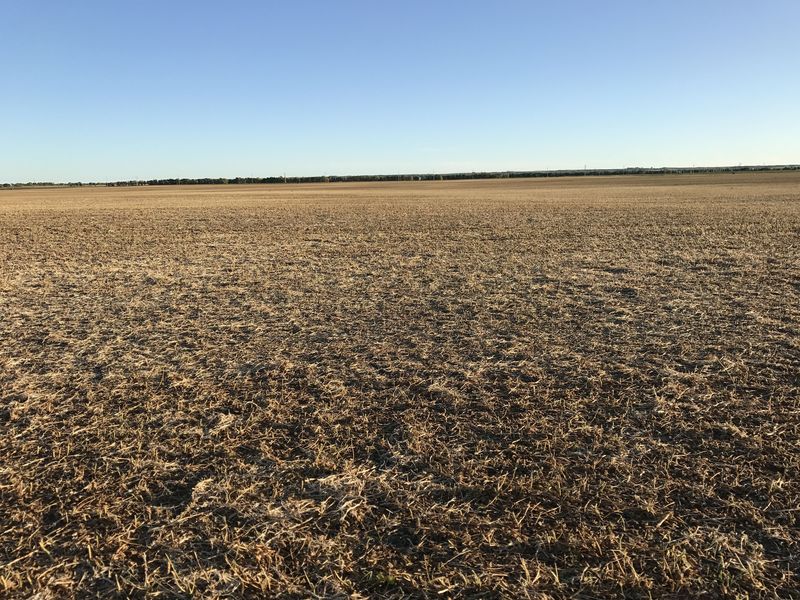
[0, 0, 800, 182]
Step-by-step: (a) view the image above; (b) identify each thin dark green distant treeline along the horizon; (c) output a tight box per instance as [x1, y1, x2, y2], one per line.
[0, 165, 800, 188]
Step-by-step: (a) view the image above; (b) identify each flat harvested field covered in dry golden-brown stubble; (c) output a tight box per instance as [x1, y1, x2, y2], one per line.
[0, 173, 800, 599]
